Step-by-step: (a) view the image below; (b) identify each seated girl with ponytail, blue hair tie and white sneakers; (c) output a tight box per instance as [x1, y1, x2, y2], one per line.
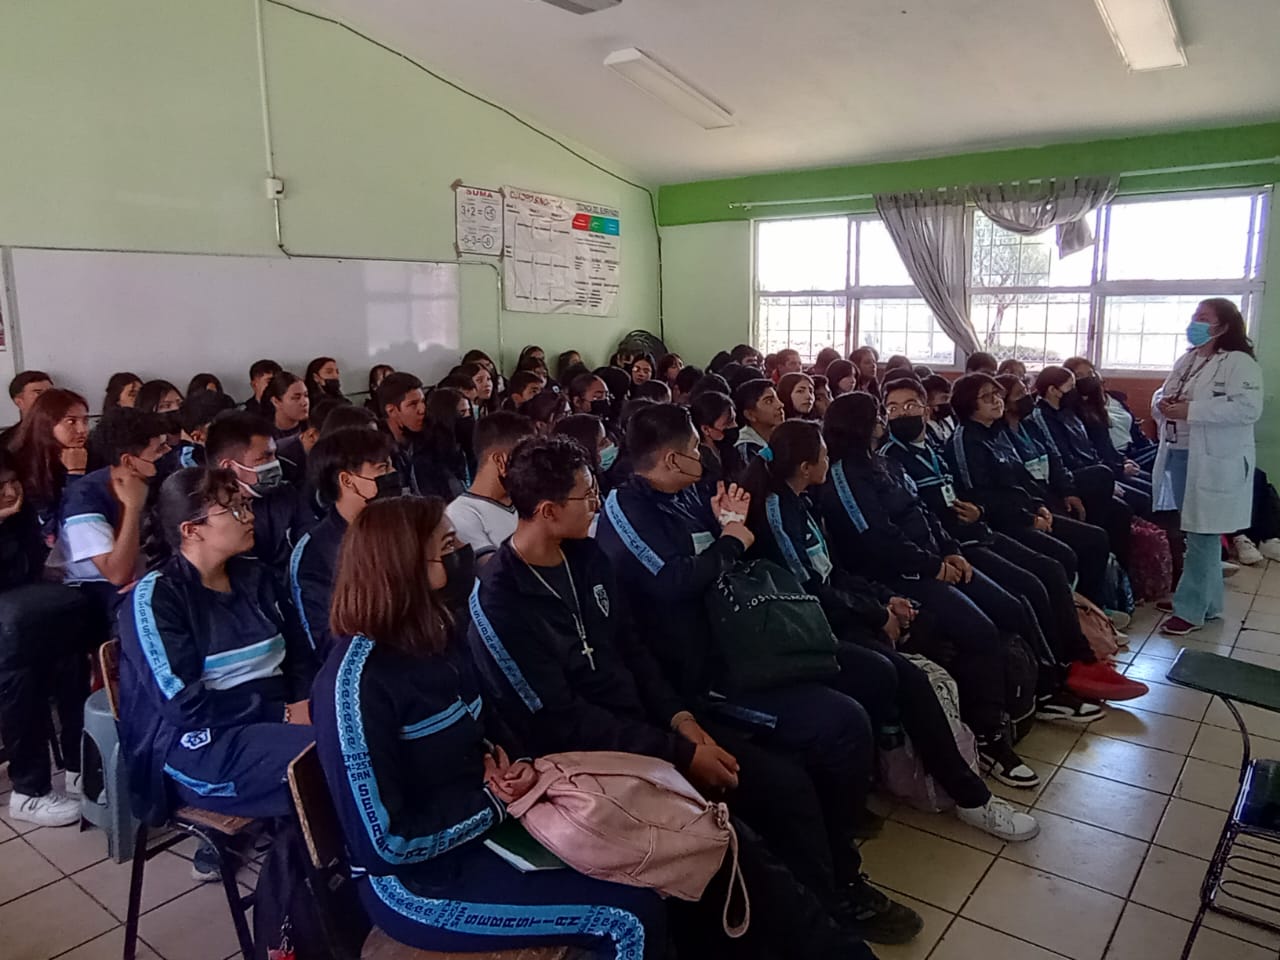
[744, 420, 1039, 842]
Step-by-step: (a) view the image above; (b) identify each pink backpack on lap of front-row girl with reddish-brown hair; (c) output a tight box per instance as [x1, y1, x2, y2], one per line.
[507, 750, 751, 937]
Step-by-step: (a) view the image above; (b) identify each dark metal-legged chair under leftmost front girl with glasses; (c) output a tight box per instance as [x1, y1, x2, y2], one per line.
[100, 640, 256, 960]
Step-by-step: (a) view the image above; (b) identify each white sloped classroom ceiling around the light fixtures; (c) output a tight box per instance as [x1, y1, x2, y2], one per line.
[292, 0, 1280, 184]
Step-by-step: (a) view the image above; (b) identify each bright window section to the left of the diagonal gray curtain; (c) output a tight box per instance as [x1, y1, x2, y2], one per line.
[755, 215, 955, 366]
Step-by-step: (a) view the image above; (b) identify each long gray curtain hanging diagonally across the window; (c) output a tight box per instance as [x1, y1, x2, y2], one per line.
[876, 189, 979, 356]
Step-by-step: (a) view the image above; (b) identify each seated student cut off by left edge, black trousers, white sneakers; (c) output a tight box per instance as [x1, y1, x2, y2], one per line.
[0, 448, 106, 827]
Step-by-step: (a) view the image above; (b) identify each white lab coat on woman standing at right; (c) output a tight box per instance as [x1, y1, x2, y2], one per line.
[1151, 351, 1262, 534]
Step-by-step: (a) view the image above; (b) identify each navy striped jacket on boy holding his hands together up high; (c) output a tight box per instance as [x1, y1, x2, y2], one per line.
[595, 476, 744, 699]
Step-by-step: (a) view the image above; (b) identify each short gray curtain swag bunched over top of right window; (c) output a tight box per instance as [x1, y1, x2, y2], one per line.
[969, 177, 1116, 257]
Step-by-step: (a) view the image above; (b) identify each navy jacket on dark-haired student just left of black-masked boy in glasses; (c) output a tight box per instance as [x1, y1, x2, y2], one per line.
[818, 454, 960, 580]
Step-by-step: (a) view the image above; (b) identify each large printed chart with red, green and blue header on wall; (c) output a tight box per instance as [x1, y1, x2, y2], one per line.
[503, 187, 622, 316]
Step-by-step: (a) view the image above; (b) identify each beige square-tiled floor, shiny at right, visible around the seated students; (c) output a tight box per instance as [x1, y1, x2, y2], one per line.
[0, 564, 1280, 960]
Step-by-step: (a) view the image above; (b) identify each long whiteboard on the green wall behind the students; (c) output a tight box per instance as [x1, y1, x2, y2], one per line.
[8, 248, 483, 413]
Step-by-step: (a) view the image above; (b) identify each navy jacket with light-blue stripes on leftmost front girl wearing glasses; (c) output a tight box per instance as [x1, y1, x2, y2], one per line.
[116, 554, 315, 823]
